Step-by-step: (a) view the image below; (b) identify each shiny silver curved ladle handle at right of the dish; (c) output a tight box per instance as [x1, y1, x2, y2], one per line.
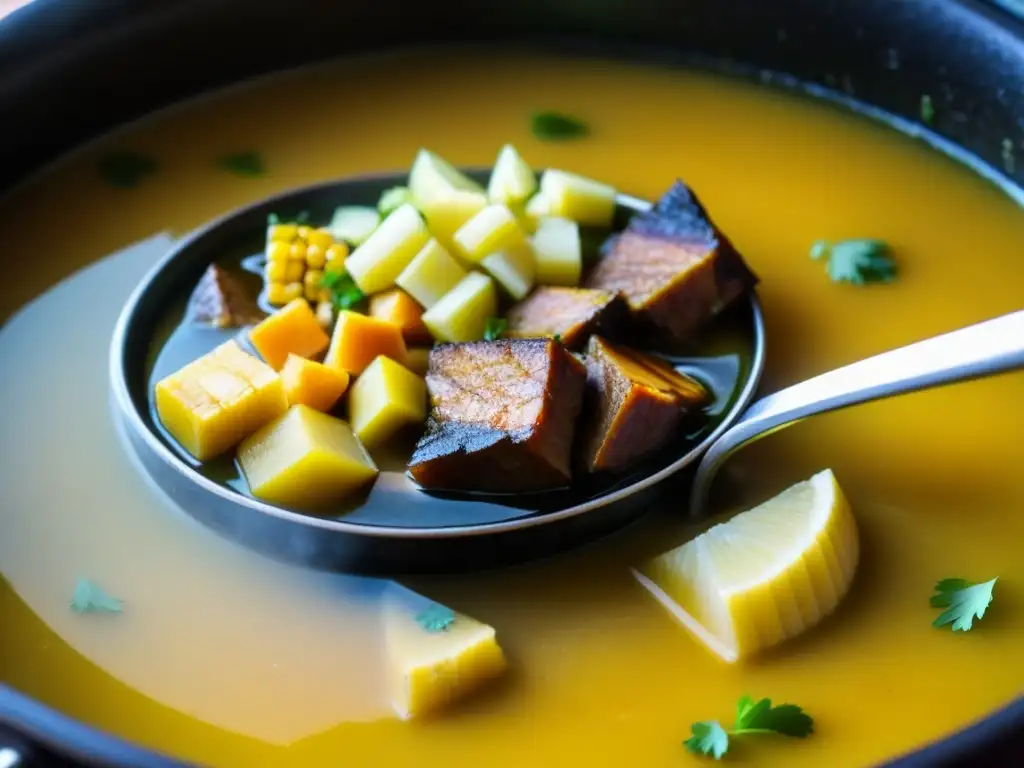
[690, 310, 1024, 517]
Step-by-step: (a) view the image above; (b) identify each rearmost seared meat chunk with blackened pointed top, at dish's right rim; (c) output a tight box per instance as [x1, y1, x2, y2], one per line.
[584, 181, 758, 341]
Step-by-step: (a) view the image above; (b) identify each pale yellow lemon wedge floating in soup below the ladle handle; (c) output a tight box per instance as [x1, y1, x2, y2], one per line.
[634, 469, 860, 663]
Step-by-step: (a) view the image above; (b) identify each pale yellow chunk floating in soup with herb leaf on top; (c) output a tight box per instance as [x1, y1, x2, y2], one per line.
[383, 584, 507, 720]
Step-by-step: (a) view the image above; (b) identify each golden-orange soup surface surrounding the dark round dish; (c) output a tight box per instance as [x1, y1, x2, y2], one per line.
[0, 52, 1024, 768]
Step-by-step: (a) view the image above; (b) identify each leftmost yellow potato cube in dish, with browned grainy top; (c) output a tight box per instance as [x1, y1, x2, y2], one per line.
[156, 340, 288, 461]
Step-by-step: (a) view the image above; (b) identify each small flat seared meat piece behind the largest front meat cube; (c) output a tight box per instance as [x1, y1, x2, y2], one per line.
[505, 286, 629, 349]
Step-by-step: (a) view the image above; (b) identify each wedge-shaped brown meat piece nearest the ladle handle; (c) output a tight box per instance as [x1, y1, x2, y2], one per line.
[583, 336, 712, 472]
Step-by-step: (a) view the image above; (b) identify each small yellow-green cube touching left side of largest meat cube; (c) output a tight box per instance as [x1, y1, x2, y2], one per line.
[348, 355, 427, 449]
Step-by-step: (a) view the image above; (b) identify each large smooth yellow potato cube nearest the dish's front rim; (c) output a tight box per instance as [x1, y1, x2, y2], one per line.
[239, 406, 378, 508]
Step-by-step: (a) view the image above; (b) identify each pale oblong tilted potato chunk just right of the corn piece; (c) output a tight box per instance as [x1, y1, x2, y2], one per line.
[345, 205, 430, 294]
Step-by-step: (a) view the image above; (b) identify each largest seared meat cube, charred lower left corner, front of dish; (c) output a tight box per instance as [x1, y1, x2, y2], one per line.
[409, 339, 587, 493]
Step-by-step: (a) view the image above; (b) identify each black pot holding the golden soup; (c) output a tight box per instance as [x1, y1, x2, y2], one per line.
[0, 0, 1024, 768]
